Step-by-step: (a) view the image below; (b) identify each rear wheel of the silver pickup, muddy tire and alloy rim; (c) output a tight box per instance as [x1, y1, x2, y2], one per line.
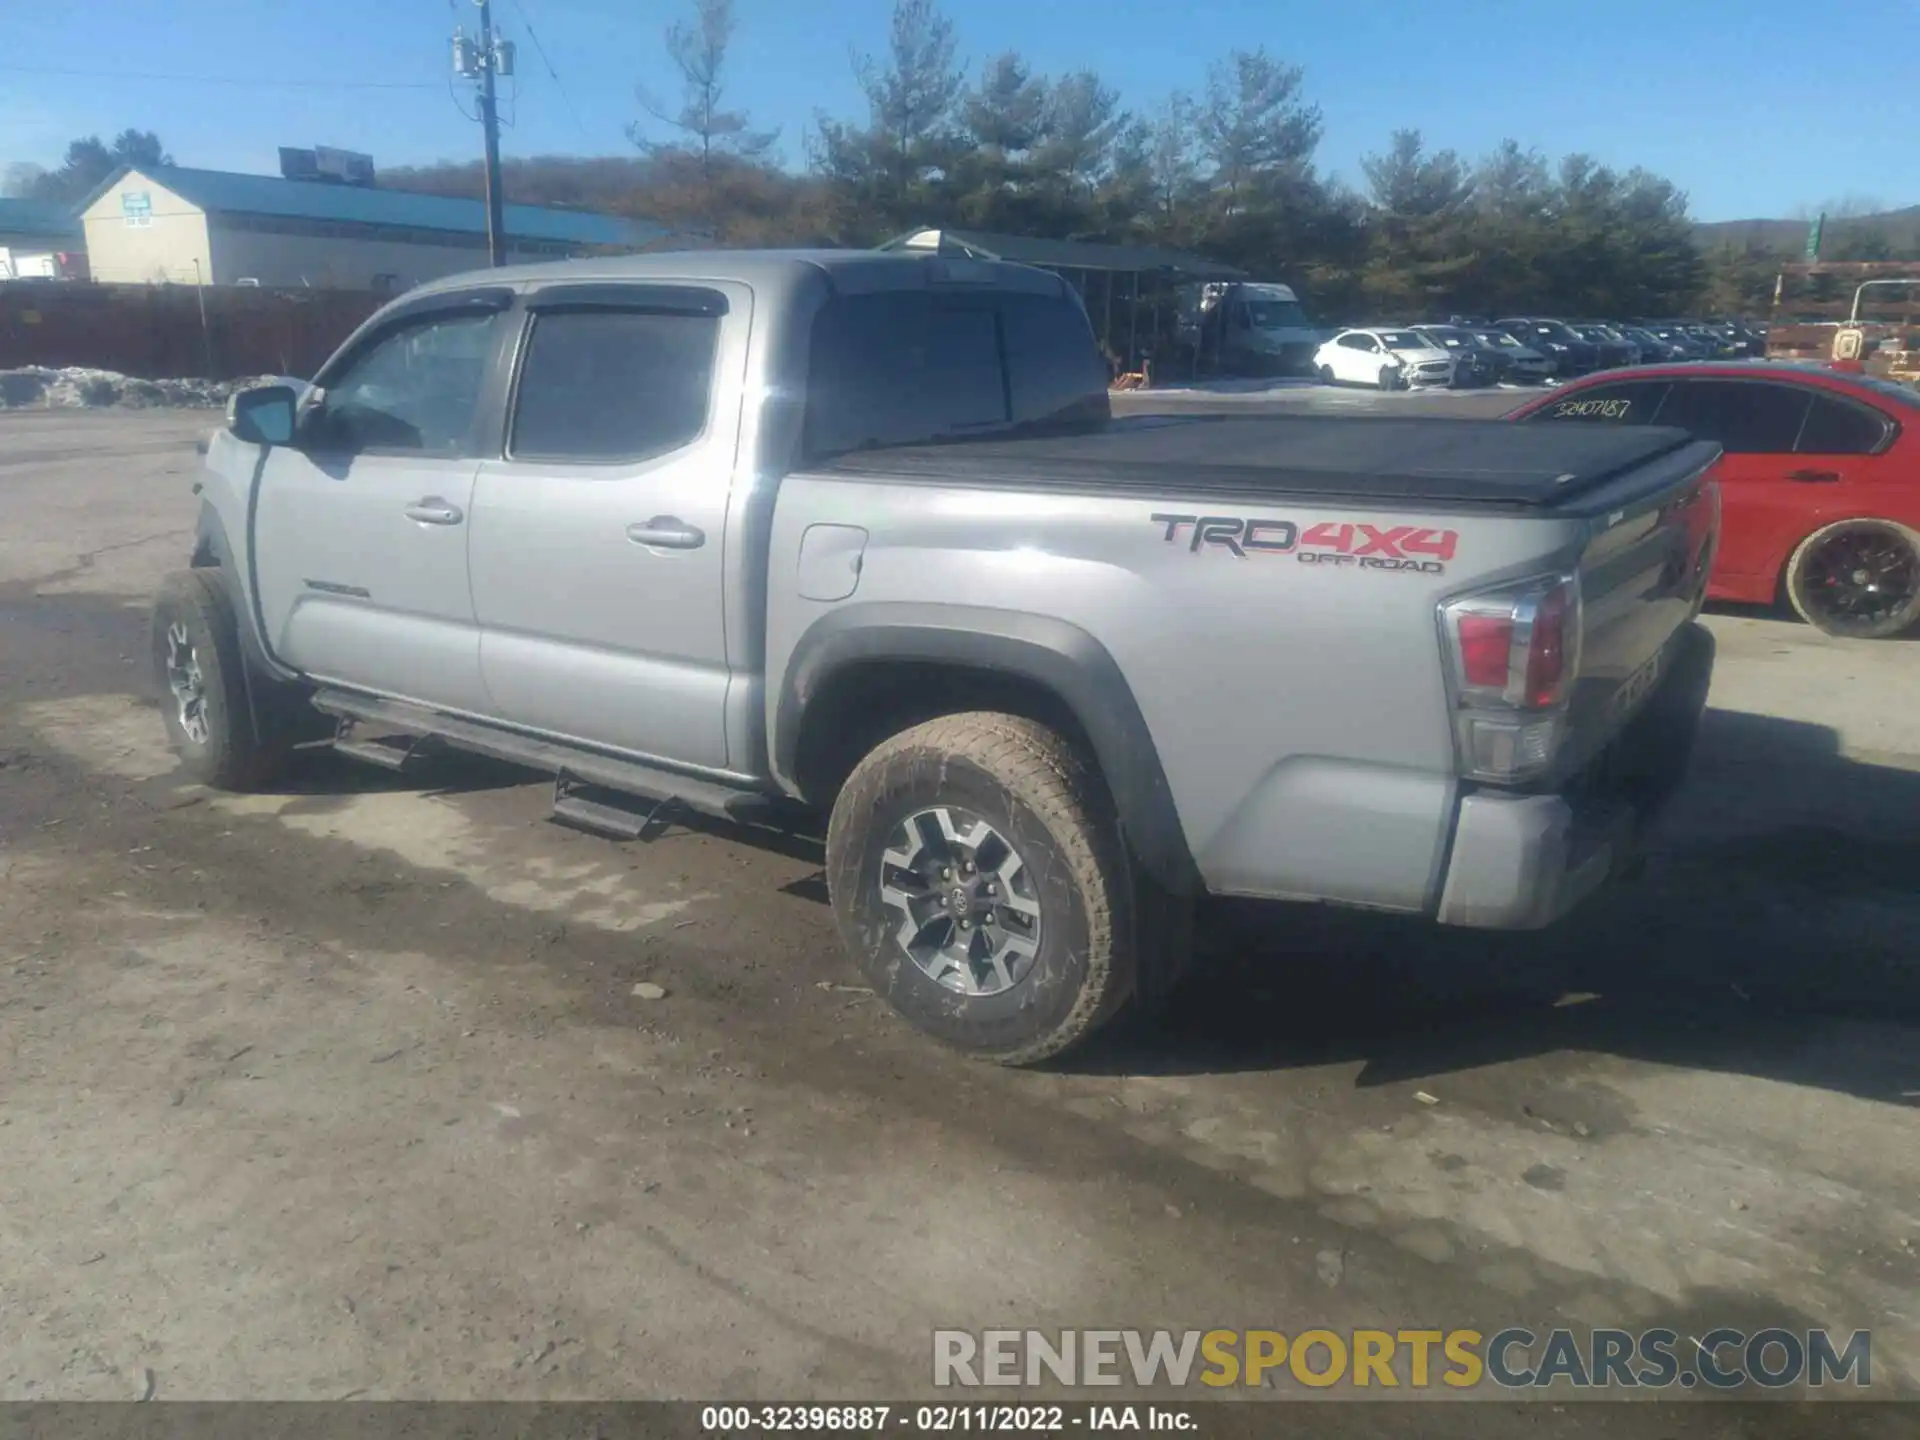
[828, 712, 1148, 1066]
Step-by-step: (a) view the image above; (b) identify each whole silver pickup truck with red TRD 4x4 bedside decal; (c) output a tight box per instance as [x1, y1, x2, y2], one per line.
[154, 252, 1718, 1064]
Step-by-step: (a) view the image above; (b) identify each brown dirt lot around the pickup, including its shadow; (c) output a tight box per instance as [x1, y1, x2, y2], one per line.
[0, 413, 1920, 1434]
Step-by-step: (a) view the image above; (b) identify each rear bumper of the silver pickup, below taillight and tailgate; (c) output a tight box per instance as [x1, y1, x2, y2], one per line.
[1436, 624, 1713, 929]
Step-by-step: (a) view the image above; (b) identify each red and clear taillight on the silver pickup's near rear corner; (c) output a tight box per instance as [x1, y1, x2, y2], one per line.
[1440, 574, 1580, 783]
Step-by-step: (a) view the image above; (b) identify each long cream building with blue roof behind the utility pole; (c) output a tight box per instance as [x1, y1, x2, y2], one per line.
[79, 165, 666, 294]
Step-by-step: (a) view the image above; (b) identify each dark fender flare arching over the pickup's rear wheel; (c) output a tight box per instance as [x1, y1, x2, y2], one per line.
[772, 601, 1200, 895]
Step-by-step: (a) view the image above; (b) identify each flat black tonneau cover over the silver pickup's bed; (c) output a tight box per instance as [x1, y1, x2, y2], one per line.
[810, 415, 1715, 509]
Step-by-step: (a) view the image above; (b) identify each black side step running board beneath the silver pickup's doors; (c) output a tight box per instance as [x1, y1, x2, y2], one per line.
[313, 689, 783, 837]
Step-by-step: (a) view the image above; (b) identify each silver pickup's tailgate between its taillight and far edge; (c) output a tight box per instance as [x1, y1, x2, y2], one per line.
[1555, 444, 1720, 776]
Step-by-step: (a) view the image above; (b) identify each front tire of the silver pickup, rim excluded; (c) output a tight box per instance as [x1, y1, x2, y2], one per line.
[154, 568, 292, 791]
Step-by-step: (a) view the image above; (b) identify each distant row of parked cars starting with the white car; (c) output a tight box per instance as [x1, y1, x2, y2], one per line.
[1313, 315, 1766, 390]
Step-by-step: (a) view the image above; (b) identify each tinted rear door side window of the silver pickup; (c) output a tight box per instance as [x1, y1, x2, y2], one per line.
[507, 301, 720, 465]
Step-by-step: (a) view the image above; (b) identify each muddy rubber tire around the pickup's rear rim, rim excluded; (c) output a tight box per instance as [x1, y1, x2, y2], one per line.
[828, 712, 1159, 1066]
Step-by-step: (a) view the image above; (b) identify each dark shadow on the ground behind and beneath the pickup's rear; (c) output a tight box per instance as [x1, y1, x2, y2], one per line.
[1071, 710, 1920, 1106]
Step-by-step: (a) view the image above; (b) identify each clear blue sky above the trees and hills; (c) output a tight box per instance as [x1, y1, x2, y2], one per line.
[0, 0, 1920, 219]
